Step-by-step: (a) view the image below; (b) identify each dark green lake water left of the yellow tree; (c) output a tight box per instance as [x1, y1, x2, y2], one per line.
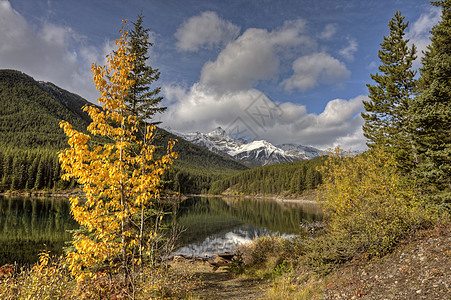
[0, 197, 77, 266]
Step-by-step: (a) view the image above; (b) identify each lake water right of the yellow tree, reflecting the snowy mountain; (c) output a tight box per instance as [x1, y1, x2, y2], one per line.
[174, 198, 321, 257]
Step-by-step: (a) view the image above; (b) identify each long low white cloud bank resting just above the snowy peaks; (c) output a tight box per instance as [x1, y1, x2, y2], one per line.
[161, 84, 367, 150]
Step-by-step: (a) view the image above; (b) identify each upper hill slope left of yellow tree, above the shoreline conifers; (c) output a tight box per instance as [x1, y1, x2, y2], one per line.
[0, 70, 89, 149]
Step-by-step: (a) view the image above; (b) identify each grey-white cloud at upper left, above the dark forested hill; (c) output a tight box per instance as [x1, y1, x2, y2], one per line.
[0, 1, 115, 101]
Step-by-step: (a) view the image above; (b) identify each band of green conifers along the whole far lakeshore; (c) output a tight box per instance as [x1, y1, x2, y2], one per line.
[0, 144, 322, 194]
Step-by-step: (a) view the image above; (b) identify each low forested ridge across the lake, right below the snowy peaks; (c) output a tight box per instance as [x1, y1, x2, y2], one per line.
[209, 157, 323, 194]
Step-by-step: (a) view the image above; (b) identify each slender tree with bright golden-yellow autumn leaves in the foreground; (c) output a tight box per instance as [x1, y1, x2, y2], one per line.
[59, 21, 177, 284]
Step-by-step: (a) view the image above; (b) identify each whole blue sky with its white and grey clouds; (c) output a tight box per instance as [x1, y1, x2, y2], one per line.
[0, 0, 440, 150]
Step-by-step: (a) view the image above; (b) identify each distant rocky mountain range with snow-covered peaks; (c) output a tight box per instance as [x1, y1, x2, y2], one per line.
[177, 127, 322, 166]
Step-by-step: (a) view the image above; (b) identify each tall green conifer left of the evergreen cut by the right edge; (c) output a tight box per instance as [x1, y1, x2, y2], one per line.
[362, 11, 416, 169]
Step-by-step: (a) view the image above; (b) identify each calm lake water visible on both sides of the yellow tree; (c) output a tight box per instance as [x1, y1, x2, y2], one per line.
[0, 197, 319, 266]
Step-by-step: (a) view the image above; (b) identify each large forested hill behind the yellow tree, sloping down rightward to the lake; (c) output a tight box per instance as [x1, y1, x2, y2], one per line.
[0, 70, 247, 193]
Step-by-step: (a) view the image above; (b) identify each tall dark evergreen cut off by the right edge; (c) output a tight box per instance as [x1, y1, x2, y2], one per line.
[410, 0, 451, 202]
